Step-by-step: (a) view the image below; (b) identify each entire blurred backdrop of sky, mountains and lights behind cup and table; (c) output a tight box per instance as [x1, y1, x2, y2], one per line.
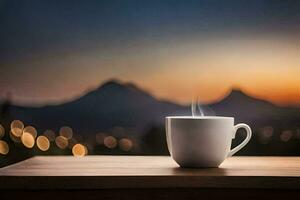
[0, 0, 300, 166]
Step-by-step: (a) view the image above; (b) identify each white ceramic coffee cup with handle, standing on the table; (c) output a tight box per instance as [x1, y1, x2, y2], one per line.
[166, 116, 252, 167]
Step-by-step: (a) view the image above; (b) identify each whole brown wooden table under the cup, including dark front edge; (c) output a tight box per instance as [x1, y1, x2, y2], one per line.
[0, 156, 300, 200]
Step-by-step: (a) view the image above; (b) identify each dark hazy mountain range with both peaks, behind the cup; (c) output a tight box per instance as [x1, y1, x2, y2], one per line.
[2, 79, 300, 133]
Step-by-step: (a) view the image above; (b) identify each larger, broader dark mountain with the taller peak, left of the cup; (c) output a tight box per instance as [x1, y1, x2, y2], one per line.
[6, 80, 186, 133]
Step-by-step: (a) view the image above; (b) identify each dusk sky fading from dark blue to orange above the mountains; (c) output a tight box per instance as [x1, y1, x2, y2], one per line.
[0, 0, 300, 106]
